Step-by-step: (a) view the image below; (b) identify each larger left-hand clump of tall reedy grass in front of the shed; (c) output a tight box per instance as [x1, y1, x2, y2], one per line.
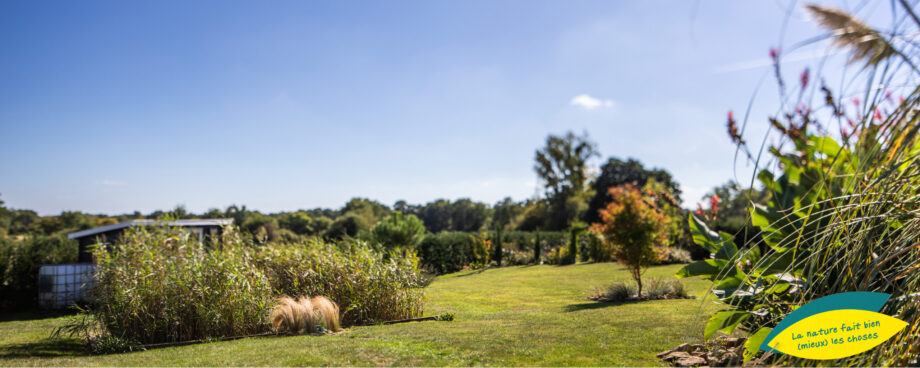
[92, 227, 274, 344]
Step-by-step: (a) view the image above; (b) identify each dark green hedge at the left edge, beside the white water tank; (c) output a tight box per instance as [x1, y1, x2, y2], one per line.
[0, 236, 77, 311]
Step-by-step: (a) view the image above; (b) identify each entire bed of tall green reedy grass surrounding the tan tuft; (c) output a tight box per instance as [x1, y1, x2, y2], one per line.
[92, 227, 424, 344]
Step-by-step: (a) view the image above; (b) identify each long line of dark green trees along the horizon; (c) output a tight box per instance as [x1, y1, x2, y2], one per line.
[0, 132, 751, 254]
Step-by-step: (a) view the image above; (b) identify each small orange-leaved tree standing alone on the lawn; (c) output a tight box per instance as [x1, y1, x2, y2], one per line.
[591, 184, 668, 297]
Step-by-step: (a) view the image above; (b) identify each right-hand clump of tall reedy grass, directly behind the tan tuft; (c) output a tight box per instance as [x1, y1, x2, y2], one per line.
[256, 240, 424, 325]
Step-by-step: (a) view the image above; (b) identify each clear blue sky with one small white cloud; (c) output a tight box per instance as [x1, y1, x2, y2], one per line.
[0, 1, 887, 214]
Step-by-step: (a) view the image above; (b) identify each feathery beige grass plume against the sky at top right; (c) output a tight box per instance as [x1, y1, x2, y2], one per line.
[805, 4, 895, 66]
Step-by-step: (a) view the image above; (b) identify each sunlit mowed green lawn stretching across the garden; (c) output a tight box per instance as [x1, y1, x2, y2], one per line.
[0, 263, 718, 366]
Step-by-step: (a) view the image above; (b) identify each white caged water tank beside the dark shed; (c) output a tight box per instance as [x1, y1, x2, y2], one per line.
[38, 263, 96, 309]
